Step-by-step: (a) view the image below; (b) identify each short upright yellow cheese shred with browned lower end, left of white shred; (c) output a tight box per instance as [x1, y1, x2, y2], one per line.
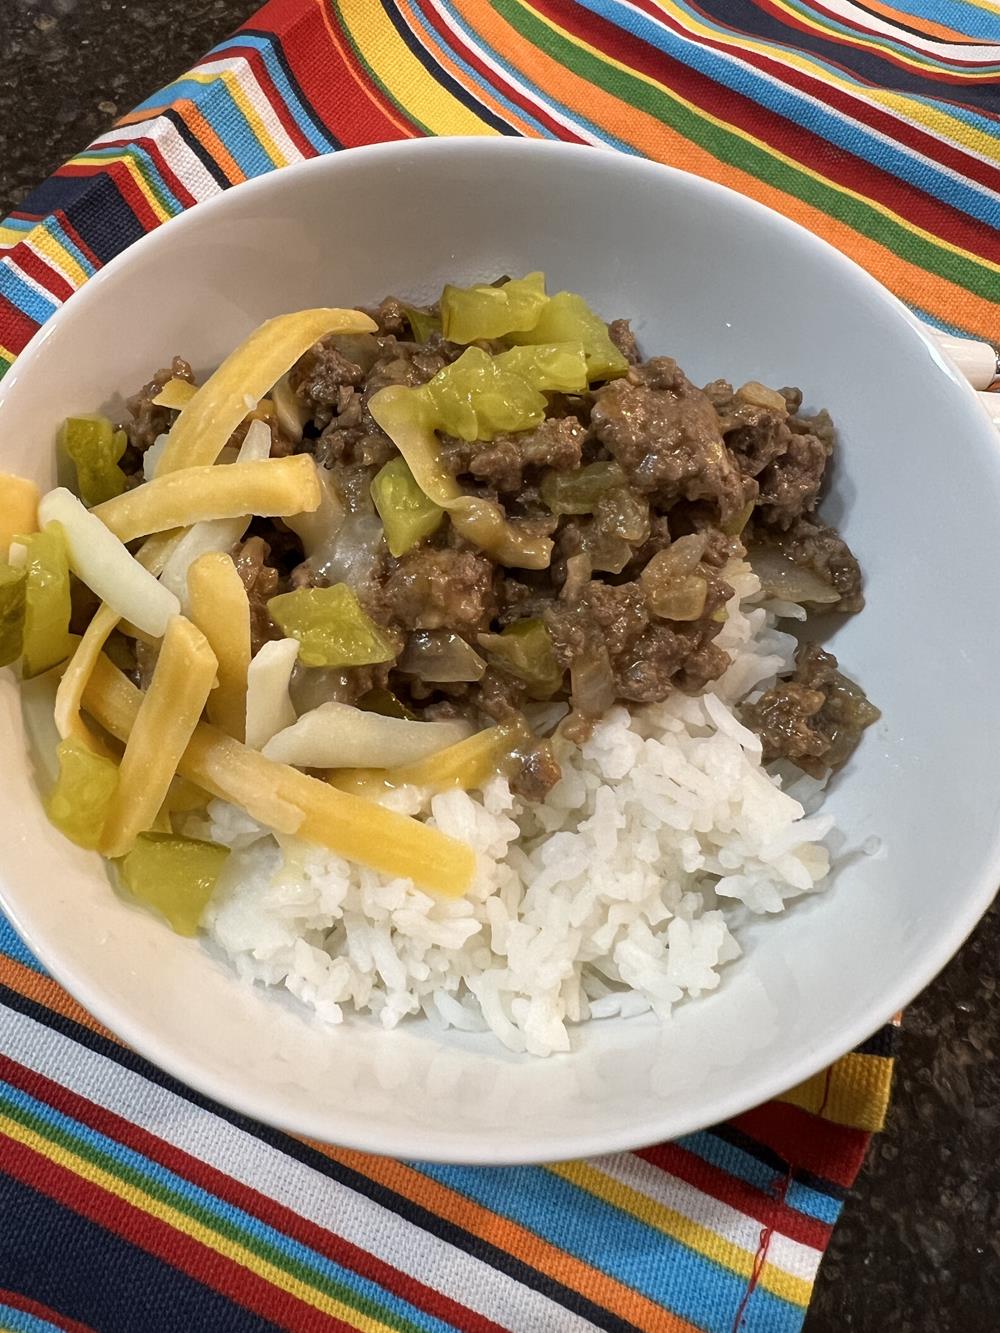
[188, 551, 251, 741]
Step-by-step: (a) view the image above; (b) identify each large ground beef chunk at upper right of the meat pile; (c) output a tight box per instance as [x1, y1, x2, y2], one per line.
[591, 356, 747, 521]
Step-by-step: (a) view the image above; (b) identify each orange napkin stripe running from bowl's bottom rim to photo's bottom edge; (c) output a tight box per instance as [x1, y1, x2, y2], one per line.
[309, 1142, 697, 1333]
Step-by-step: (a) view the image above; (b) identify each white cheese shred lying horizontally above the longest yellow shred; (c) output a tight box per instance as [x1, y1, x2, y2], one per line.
[261, 702, 472, 768]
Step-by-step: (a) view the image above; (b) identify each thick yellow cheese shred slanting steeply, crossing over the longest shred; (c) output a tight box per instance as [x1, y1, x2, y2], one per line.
[100, 616, 219, 857]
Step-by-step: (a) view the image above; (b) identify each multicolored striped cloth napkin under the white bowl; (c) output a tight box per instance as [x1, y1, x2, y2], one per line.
[0, 0, 1000, 1333]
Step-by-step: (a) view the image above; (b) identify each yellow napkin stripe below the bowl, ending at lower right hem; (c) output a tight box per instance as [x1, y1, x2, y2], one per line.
[548, 1162, 812, 1308]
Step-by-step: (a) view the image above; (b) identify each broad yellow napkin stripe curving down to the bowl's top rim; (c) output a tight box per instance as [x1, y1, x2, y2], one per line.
[339, 0, 500, 137]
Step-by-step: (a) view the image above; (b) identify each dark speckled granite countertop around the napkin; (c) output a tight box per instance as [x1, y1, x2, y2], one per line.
[0, 0, 1000, 1333]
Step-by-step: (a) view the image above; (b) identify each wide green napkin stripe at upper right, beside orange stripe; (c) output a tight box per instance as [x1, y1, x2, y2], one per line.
[504, 0, 1000, 301]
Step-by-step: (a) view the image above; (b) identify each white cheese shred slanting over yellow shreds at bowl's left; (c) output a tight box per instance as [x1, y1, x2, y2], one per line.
[39, 487, 180, 639]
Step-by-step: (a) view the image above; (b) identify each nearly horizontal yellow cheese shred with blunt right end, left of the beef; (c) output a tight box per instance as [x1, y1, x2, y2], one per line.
[91, 453, 321, 541]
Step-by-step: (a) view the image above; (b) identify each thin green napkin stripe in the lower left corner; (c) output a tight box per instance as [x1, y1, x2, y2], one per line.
[0, 1093, 424, 1333]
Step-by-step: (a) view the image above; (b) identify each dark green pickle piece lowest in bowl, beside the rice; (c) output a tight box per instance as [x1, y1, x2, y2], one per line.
[120, 833, 229, 934]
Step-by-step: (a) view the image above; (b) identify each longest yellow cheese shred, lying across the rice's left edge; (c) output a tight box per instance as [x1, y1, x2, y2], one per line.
[84, 657, 476, 897]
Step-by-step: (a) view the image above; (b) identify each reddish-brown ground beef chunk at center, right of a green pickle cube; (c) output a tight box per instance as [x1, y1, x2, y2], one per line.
[381, 547, 496, 635]
